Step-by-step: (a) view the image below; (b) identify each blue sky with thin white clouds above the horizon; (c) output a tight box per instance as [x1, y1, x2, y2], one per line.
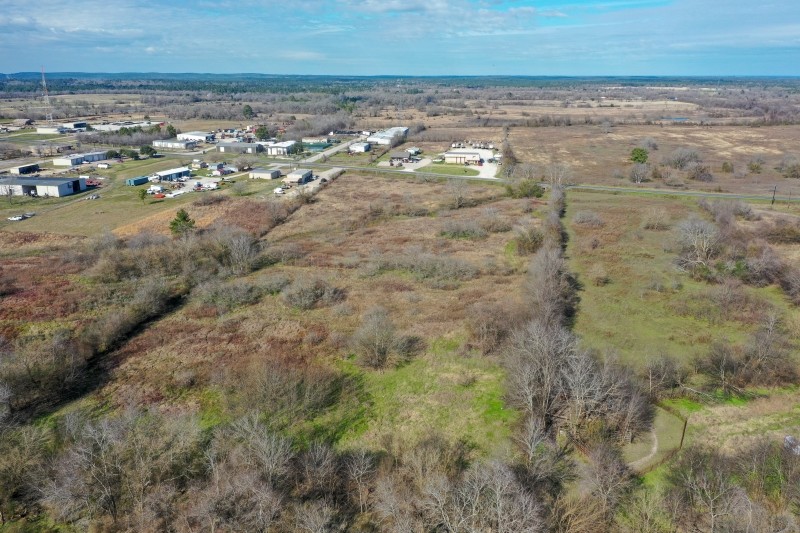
[0, 0, 800, 76]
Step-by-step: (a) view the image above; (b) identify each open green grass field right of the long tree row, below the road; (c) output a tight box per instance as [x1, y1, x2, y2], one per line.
[567, 192, 792, 367]
